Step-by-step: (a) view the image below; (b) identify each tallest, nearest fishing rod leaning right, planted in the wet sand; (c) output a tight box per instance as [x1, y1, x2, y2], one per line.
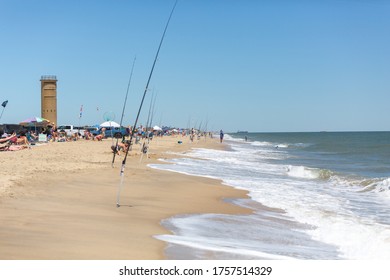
[116, 0, 178, 207]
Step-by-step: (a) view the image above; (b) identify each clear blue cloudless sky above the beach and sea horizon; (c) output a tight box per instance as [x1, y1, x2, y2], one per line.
[0, 0, 390, 132]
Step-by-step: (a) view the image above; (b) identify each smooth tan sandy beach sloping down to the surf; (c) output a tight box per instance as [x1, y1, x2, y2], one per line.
[0, 136, 249, 260]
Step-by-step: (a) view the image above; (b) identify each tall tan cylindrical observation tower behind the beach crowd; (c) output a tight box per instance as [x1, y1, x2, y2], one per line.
[41, 76, 57, 125]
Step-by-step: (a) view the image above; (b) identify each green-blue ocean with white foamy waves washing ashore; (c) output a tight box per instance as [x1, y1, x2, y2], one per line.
[150, 132, 390, 260]
